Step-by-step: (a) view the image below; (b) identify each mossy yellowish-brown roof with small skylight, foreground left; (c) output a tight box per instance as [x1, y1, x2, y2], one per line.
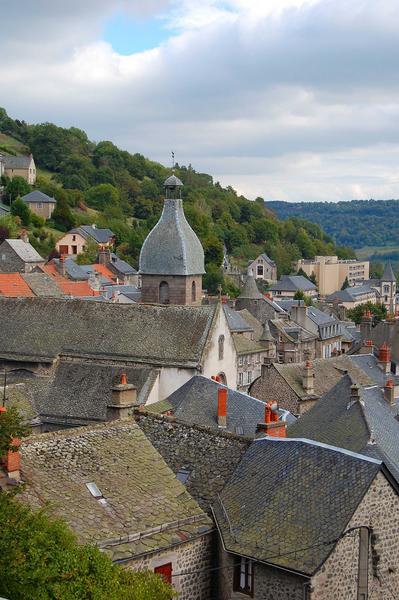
[20, 420, 212, 560]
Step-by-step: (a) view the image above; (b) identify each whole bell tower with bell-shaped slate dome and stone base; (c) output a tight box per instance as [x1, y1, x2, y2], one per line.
[139, 175, 205, 306]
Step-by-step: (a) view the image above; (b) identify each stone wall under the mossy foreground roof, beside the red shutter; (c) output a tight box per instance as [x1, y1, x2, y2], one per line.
[127, 533, 217, 600]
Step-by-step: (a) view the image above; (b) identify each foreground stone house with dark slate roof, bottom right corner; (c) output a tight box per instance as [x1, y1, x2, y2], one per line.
[212, 438, 399, 600]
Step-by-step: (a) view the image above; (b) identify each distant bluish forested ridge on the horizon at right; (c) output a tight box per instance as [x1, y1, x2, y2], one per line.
[265, 200, 399, 248]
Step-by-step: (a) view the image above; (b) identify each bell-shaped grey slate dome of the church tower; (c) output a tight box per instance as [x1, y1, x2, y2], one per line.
[139, 198, 205, 275]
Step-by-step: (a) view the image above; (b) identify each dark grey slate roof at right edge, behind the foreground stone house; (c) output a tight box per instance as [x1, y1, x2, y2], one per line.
[287, 375, 399, 478]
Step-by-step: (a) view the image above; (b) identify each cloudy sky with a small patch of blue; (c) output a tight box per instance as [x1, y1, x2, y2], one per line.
[0, 0, 399, 202]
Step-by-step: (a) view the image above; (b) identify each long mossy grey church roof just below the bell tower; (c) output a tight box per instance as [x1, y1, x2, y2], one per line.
[0, 298, 219, 368]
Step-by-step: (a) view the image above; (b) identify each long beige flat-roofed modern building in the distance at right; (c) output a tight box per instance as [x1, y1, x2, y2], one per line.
[295, 256, 370, 296]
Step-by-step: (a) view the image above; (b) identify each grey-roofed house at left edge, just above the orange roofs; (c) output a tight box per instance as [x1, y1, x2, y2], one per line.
[0, 236, 45, 273]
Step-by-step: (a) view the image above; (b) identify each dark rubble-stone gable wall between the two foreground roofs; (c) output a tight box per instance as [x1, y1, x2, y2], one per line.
[134, 411, 251, 513]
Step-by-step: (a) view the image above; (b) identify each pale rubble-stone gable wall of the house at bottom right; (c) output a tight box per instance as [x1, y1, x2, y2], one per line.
[311, 473, 399, 600]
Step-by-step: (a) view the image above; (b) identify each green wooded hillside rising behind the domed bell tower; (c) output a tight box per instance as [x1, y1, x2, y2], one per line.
[0, 108, 353, 289]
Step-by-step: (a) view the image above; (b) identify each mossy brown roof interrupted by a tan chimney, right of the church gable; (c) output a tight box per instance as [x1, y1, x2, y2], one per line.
[249, 354, 374, 400]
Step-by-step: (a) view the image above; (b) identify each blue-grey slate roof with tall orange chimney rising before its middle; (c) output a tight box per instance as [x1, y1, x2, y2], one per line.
[161, 375, 295, 437]
